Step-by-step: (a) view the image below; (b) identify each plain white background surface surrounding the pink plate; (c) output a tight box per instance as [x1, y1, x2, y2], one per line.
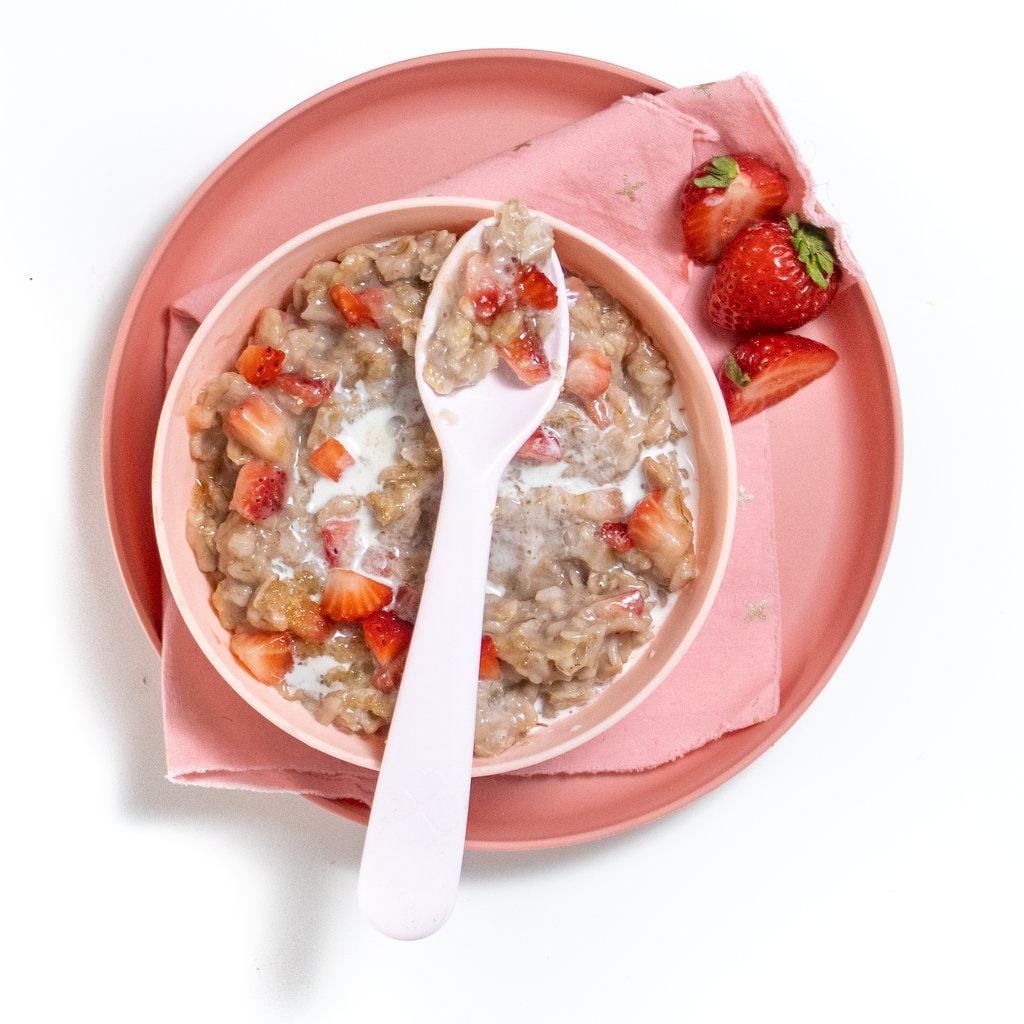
[0, 0, 1024, 1024]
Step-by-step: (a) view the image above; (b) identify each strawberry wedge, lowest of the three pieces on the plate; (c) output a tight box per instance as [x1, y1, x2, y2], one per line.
[718, 334, 839, 423]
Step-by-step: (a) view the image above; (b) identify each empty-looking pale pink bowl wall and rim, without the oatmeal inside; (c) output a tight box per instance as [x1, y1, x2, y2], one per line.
[153, 198, 736, 775]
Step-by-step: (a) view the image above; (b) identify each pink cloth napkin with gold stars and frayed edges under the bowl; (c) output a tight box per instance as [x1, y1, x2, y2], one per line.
[163, 76, 857, 802]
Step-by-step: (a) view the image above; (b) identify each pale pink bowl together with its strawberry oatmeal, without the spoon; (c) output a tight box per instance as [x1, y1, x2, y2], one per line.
[153, 198, 736, 775]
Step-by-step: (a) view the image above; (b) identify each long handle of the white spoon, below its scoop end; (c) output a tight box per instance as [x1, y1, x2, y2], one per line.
[358, 465, 498, 939]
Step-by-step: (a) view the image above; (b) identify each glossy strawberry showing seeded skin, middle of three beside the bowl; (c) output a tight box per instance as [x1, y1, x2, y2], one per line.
[707, 214, 840, 334]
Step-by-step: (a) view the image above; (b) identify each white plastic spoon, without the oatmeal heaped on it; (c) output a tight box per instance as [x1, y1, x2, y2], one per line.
[359, 211, 569, 939]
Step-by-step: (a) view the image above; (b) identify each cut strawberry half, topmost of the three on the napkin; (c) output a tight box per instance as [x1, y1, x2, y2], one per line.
[682, 153, 790, 265]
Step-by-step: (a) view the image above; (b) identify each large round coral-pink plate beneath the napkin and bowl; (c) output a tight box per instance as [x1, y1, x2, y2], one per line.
[102, 50, 902, 850]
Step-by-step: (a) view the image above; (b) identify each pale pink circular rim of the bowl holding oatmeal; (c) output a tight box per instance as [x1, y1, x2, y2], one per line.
[151, 196, 737, 777]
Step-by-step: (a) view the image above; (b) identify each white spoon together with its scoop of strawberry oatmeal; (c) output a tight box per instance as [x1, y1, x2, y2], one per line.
[359, 200, 569, 939]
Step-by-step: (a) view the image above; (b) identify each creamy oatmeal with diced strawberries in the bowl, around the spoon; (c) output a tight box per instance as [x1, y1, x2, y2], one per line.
[186, 201, 696, 756]
